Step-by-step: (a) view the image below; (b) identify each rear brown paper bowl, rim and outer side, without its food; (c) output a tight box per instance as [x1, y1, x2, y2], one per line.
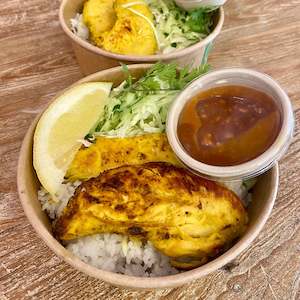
[59, 0, 224, 75]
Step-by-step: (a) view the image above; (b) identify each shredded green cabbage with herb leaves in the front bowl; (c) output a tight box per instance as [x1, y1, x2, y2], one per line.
[93, 63, 209, 137]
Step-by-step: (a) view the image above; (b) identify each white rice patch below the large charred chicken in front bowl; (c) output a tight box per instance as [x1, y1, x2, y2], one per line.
[66, 233, 178, 277]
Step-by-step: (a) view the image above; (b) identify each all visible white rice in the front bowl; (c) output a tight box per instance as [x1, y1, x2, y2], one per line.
[38, 181, 251, 277]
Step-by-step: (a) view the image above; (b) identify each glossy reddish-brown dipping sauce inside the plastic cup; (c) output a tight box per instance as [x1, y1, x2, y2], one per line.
[177, 86, 282, 166]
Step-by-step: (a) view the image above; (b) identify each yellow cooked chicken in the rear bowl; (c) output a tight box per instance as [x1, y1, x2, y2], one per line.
[83, 0, 157, 55]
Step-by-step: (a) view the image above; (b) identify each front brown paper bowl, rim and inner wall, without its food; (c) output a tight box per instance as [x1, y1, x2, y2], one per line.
[18, 65, 278, 289]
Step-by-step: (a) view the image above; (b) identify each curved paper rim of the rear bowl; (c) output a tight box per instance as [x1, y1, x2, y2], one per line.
[59, 0, 225, 63]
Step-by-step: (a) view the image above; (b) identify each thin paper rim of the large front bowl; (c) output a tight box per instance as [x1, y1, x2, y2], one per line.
[17, 64, 279, 289]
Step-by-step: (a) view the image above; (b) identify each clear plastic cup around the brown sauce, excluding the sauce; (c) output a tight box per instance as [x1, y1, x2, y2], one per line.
[166, 68, 294, 181]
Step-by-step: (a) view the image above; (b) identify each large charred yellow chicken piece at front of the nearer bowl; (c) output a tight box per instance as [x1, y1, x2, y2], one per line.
[54, 163, 248, 269]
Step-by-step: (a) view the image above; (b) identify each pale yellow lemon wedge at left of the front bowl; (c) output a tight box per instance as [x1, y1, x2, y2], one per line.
[33, 82, 112, 197]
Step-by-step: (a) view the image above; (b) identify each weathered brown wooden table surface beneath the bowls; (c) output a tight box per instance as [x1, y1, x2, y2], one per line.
[0, 0, 300, 300]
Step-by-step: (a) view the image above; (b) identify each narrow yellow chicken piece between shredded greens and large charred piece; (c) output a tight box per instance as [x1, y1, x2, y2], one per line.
[66, 133, 179, 180]
